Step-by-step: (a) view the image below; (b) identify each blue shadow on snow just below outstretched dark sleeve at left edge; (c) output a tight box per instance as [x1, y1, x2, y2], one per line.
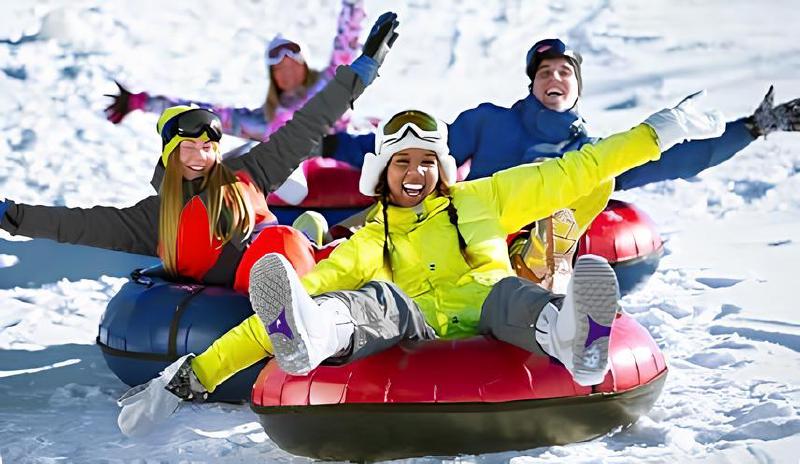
[0, 239, 159, 288]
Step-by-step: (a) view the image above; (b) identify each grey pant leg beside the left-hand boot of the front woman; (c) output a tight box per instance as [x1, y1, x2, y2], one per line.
[323, 281, 436, 364]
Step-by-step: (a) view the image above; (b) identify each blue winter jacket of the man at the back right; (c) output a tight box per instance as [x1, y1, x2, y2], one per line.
[332, 95, 755, 190]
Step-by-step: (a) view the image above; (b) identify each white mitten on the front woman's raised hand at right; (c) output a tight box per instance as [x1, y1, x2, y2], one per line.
[644, 91, 725, 153]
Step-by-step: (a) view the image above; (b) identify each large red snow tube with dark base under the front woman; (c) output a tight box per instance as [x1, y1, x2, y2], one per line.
[252, 315, 667, 461]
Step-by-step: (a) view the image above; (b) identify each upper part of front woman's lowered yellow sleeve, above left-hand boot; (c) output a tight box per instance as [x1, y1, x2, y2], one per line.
[300, 228, 383, 296]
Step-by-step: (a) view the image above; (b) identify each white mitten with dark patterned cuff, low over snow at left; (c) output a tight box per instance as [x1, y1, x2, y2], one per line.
[117, 354, 208, 437]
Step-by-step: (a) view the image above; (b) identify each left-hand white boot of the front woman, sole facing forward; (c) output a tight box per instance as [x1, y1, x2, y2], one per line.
[250, 253, 355, 375]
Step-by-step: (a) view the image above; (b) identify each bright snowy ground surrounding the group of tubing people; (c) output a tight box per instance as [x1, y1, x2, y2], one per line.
[0, 0, 800, 464]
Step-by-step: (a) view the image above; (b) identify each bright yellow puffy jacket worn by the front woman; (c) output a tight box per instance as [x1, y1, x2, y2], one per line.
[302, 124, 660, 338]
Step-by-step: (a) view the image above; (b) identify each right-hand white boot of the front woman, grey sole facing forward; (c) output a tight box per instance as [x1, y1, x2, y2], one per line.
[536, 255, 619, 386]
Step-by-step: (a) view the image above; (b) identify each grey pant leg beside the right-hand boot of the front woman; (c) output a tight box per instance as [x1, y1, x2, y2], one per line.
[478, 277, 564, 354]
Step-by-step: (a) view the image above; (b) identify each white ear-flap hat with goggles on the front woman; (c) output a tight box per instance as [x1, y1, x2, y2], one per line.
[358, 110, 457, 197]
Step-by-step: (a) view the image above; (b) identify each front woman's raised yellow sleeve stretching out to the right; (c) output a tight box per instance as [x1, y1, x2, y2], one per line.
[474, 124, 661, 233]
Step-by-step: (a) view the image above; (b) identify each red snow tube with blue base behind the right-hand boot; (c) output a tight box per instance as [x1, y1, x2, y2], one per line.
[577, 200, 664, 295]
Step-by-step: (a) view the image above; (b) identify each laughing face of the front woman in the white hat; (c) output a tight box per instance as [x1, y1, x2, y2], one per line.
[386, 148, 439, 208]
